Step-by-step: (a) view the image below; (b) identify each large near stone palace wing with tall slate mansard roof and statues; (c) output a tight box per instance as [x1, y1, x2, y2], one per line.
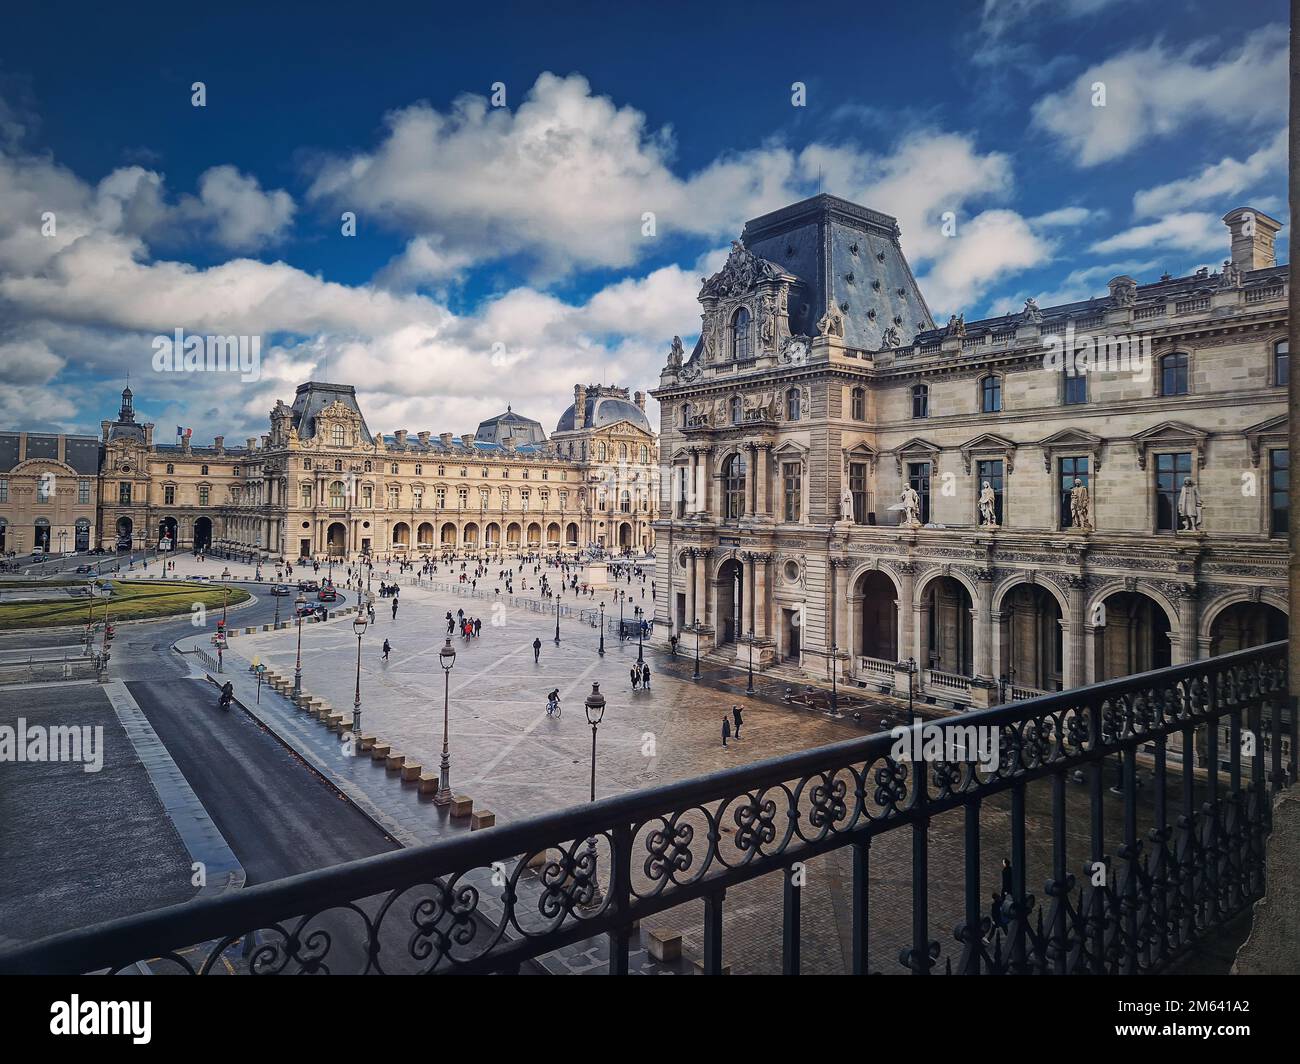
[653, 195, 1288, 706]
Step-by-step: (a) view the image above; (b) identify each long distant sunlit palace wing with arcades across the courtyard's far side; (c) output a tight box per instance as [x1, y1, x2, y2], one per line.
[0, 381, 659, 559]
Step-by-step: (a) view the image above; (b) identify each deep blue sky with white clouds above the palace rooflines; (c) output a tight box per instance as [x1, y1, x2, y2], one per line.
[0, 0, 1288, 440]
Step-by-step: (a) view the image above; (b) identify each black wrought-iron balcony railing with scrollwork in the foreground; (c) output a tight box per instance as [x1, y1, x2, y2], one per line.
[0, 643, 1296, 974]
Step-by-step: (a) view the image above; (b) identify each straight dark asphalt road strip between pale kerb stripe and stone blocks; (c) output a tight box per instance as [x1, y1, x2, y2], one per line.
[126, 679, 399, 884]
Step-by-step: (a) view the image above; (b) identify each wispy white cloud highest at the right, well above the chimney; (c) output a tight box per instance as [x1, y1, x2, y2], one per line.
[1034, 25, 1287, 166]
